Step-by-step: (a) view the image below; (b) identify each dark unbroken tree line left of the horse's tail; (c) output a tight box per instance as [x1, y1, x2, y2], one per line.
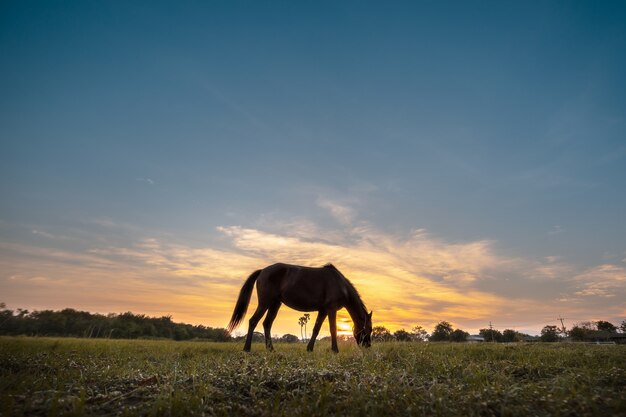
[0, 303, 231, 342]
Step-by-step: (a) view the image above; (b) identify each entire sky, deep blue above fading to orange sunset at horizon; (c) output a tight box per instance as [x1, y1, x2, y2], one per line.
[0, 0, 626, 334]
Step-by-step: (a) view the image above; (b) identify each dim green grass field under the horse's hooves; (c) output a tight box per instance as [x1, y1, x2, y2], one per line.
[0, 337, 626, 416]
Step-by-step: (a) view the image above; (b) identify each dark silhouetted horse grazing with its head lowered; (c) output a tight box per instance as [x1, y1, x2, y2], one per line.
[228, 263, 372, 352]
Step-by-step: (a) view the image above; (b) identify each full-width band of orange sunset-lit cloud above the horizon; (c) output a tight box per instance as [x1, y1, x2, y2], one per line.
[0, 220, 626, 333]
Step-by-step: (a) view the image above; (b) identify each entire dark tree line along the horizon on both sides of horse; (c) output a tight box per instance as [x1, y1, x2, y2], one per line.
[0, 303, 626, 343]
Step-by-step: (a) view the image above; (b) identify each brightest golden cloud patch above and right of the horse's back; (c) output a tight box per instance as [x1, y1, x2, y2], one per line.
[214, 226, 508, 327]
